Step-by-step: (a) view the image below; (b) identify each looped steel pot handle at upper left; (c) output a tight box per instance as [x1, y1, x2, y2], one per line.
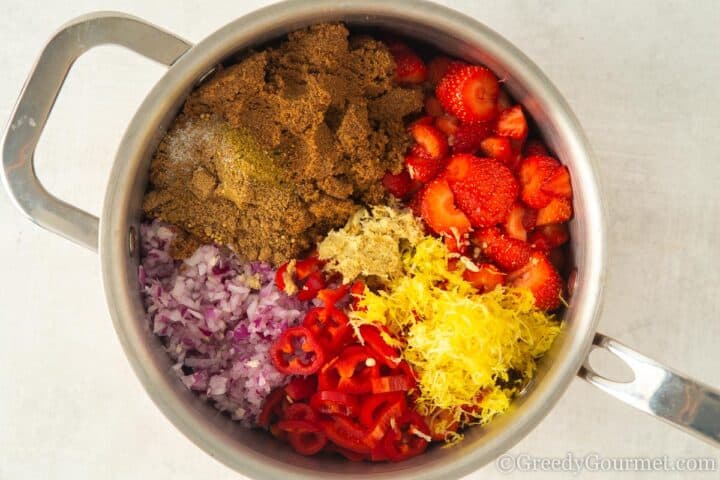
[2, 12, 192, 251]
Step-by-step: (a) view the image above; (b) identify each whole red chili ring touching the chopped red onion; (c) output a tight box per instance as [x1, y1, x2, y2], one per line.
[270, 327, 325, 375]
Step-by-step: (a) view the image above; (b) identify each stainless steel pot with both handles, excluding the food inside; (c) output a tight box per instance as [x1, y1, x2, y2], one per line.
[3, 0, 720, 479]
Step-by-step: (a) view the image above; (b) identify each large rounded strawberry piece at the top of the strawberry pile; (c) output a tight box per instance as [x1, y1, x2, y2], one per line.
[435, 65, 500, 122]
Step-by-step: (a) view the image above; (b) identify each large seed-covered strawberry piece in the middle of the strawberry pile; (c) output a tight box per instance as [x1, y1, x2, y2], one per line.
[445, 153, 518, 227]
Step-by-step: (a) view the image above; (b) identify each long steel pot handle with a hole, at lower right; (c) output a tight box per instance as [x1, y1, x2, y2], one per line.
[578, 333, 720, 447]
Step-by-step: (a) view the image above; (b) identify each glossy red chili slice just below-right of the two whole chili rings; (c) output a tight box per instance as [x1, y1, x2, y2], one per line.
[318, 345, 379, 394]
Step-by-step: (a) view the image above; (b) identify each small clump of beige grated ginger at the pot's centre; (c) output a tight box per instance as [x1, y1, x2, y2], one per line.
[318, 206, 425, 283]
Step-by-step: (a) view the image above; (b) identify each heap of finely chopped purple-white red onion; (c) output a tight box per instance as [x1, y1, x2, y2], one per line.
[138, 220, 311, 427]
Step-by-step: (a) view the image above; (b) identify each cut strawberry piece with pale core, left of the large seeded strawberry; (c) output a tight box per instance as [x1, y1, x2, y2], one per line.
[420, 179, 470, 237]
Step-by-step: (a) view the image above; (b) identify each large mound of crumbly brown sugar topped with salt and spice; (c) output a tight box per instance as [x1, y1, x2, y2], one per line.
[144, 24, 423, 264]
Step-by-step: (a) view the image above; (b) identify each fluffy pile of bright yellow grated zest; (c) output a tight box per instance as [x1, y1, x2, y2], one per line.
[351, 237, 560, 430]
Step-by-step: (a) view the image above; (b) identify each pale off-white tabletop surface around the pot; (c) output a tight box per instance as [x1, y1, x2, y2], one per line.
[0, 0, 720, 479]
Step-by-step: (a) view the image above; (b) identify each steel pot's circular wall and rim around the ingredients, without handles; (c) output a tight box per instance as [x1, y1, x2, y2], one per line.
[101, 2, 603, 478]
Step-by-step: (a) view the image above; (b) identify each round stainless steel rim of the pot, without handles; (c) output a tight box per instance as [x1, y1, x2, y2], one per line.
[99, 0, 606, 479]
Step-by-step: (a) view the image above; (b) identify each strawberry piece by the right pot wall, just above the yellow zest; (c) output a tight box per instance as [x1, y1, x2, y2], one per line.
[508, 252, 562, 310]
